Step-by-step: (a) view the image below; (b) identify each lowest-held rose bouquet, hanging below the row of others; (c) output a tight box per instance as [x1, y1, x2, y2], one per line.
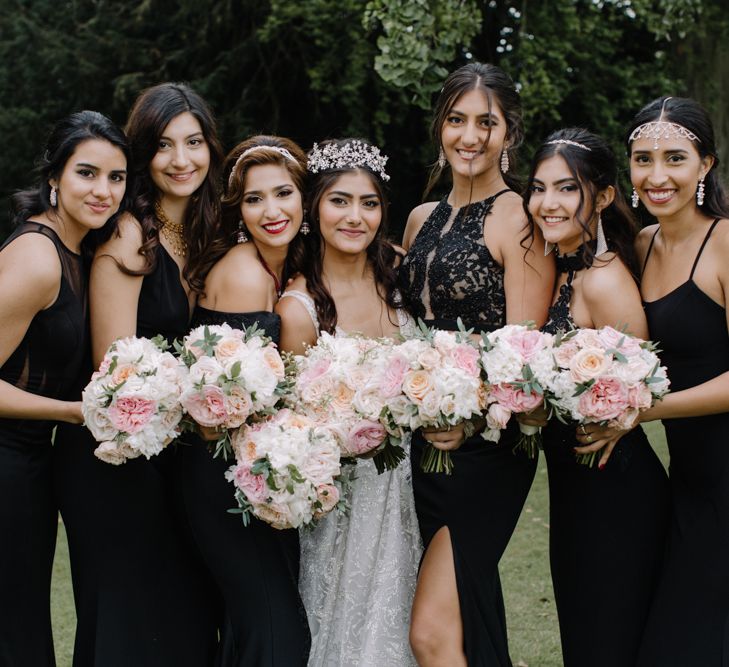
[225, 409, 341, 529]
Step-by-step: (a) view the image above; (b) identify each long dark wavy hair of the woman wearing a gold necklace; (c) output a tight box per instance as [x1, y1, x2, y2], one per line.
[115, 83, 223, 292]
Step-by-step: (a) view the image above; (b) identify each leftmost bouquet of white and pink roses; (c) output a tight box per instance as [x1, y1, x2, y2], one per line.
[82, 336, 182, 465]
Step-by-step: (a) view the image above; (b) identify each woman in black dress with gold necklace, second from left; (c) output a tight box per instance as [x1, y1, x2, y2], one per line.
[55, 83, 221, 667]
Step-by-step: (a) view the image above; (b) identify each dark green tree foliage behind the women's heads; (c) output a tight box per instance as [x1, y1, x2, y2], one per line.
[0, 0, 729, 238]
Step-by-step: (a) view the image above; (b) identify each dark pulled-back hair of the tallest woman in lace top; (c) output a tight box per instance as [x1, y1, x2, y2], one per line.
[423, 62, 524, 198]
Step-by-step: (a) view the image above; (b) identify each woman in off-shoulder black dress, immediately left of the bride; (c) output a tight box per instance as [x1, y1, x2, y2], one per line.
[176, 136, 311, 667]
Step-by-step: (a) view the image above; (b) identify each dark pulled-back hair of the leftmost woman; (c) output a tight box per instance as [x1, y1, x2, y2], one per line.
[10, 111, 131, 252]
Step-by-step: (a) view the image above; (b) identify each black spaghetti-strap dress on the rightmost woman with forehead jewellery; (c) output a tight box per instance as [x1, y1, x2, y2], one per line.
[638, 220, 729, 667]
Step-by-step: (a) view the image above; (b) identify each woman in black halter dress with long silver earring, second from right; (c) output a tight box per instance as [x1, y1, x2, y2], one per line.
[522, 128, 669, 667]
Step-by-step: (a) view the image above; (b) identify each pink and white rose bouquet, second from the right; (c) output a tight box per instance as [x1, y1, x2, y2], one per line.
[481, 324, 554, 458]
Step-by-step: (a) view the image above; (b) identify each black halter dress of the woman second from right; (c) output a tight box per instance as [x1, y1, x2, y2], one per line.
[542, 270, 670, 667]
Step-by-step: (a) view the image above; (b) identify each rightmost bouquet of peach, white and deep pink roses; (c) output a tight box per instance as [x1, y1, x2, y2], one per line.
[549, 327, 670, 466]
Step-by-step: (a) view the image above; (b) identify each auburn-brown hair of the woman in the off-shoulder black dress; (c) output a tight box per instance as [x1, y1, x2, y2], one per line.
[200, 134, 307, 284]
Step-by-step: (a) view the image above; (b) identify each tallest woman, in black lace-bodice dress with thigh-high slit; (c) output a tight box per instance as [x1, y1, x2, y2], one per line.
[401, 63, 554, 667]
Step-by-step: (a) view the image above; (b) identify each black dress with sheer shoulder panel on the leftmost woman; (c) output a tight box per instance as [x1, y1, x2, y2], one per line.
[0, 222, 88, 667]
